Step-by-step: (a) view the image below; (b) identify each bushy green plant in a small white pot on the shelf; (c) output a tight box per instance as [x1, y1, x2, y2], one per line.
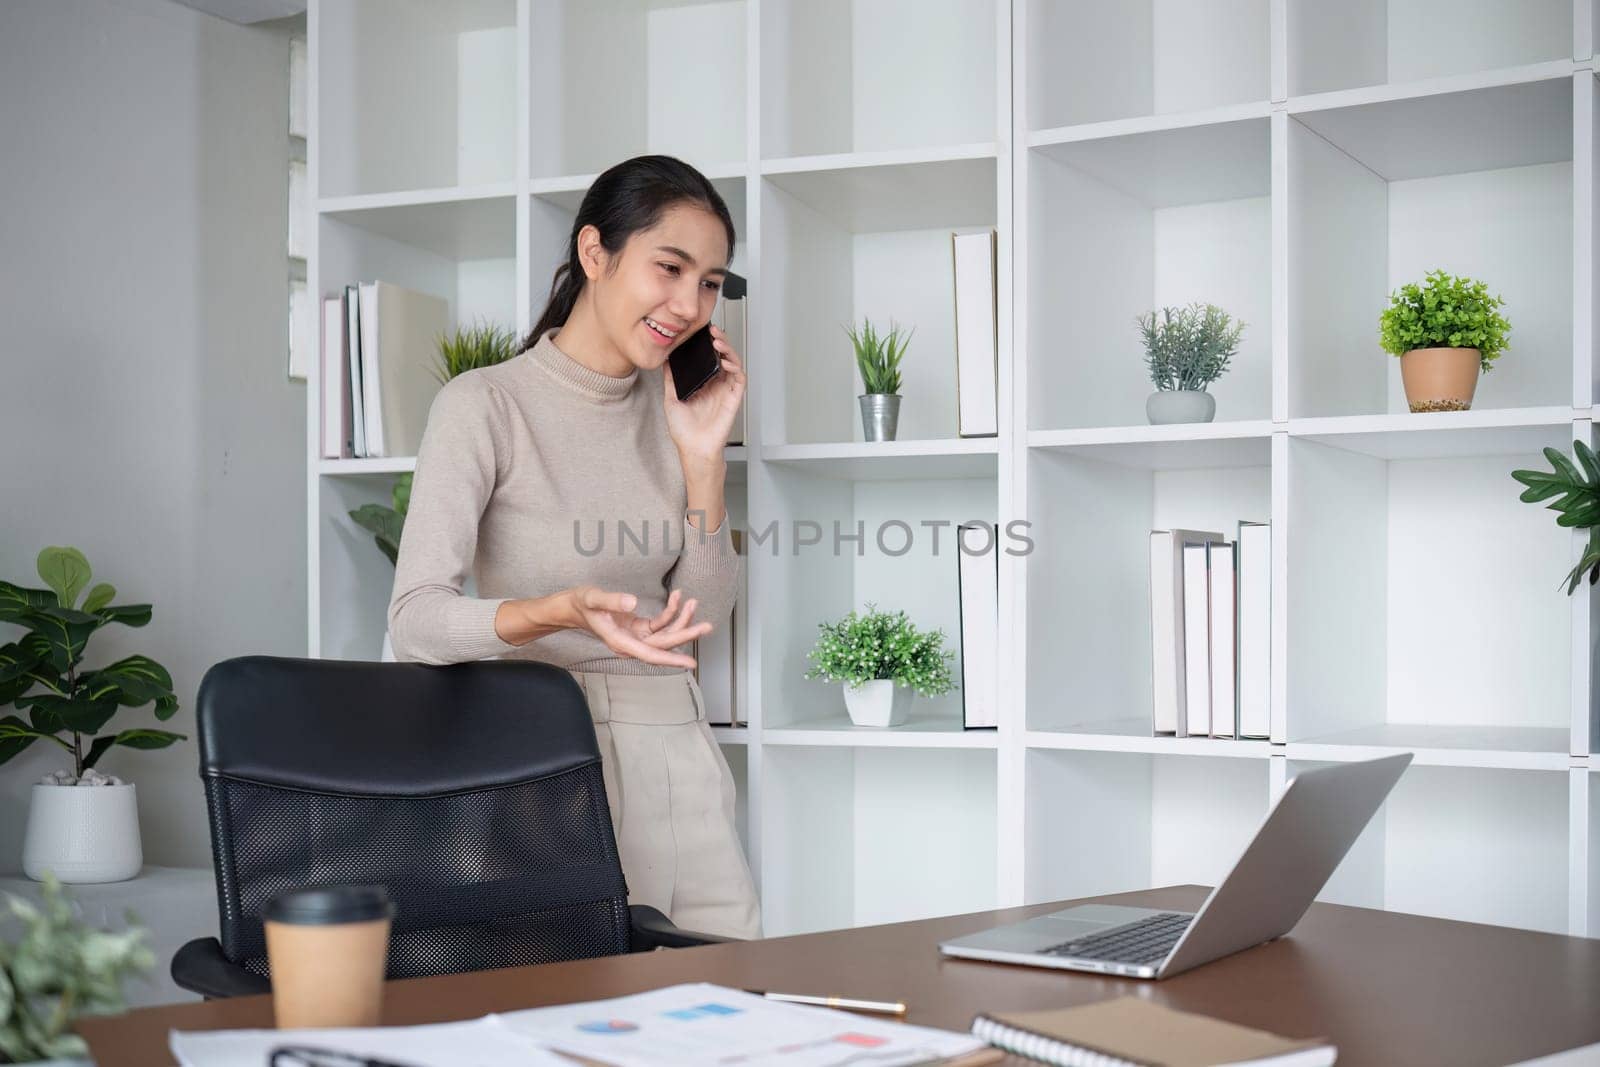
[805, 603, 955, 726]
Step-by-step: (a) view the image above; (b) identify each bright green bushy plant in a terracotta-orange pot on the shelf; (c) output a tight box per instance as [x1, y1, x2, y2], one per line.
[1378, 270, 1510, 411]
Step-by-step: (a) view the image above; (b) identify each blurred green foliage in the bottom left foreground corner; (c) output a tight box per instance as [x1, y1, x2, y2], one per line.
[0, 878, 155, 1067]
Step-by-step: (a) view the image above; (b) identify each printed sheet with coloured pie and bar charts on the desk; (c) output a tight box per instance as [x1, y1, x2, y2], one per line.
[496, 984, 987, 1067]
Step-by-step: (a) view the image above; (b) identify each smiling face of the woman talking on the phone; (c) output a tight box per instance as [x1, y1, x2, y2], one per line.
[594, 205, 728, 370]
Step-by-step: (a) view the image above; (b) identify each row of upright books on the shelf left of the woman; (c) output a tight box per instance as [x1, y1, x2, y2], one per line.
[322, 282, 450, 459]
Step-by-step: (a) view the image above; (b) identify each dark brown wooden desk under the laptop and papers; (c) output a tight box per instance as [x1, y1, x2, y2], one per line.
[78, 886, 1600, 1067]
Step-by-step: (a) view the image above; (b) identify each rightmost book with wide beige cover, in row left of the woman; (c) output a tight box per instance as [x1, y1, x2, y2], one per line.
[360, 282, 450, 458]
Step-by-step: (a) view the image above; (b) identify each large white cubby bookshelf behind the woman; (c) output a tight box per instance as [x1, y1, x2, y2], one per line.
[307, 0, 1600, 936]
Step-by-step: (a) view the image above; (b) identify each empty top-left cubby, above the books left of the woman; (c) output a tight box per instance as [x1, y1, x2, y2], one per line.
[321, 0, 520, 197]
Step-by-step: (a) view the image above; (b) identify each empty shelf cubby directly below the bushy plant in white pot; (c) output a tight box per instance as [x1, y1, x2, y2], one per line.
[760, 747, 997, 936]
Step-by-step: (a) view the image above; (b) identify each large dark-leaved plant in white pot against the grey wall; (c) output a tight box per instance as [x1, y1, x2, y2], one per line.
[0, 547, 184, 883]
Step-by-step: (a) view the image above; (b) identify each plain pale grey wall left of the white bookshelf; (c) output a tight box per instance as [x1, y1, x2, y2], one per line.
[0, 0, 306, 870]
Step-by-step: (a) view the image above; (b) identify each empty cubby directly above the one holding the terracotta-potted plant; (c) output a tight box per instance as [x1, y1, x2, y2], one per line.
[1286, 0, 1590, 96]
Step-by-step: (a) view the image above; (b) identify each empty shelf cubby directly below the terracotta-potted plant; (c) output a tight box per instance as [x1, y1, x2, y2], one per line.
[1282, 422, 1589, 766]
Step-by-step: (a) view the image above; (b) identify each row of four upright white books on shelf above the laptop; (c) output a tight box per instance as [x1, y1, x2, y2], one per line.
[1150, 520, 1272, 739]
